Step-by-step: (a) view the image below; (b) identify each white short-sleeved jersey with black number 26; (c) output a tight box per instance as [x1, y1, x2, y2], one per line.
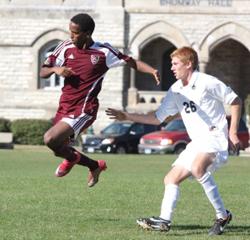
[156, 71, 237, 150]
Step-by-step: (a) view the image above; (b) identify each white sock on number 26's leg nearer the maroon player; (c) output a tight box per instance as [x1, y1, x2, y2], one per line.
[160, 184, 180, 221]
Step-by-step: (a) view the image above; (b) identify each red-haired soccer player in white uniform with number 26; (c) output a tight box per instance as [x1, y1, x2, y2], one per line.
[106, 47, 241, 235]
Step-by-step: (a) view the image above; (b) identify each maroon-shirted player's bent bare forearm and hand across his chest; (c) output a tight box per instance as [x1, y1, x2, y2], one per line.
[40, 66, 75, 78]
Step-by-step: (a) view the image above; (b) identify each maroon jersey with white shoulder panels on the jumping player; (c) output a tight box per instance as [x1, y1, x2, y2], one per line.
[43, 40, 130, 121]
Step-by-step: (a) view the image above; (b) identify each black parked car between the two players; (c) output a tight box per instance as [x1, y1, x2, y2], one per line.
[82, 121, 160, 153]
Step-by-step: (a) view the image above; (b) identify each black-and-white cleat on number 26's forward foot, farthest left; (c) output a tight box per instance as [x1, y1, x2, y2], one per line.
[136, 217, 171, 232]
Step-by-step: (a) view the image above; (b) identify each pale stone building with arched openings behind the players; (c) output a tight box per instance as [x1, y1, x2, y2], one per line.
[0, 0, 250, 131]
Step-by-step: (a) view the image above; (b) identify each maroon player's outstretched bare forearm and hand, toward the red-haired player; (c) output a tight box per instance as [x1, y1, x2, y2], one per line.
[127, 58, 161, 85]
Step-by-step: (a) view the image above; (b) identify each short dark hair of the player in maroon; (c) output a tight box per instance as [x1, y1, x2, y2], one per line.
[70, 13, 95, 34]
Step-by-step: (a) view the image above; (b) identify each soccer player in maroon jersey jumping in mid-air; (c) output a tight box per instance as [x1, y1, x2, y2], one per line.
[40, 13, 160, 187]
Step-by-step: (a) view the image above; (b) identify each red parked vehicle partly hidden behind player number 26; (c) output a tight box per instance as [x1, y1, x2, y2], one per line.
[138, 116, 249, 155]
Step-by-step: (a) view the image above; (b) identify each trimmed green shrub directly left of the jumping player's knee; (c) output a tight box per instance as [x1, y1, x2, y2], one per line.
[11, 119, 52, 145]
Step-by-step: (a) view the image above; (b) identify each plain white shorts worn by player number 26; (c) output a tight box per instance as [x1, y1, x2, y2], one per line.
[172, 141, 228, 172]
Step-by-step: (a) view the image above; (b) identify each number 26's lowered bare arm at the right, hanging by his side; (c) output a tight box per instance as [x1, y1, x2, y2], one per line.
[229, 97, 242, 151]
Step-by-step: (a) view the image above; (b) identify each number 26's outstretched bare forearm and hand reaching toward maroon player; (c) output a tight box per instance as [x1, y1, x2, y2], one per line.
[106, 108, 161, 125]
